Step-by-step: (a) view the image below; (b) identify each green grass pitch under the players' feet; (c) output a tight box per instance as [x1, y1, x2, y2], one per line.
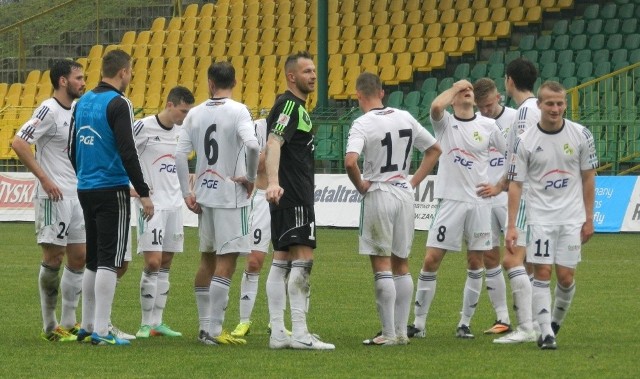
[0, 223, 640, 378]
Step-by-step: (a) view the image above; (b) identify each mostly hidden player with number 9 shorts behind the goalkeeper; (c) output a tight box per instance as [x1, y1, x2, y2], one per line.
[231, 118, 271, 337]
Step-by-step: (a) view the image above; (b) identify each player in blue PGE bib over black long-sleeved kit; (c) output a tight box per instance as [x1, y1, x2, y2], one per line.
[69, 50, 154, 346]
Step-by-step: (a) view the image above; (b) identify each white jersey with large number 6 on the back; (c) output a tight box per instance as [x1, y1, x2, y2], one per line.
[176, 98, 257, 208]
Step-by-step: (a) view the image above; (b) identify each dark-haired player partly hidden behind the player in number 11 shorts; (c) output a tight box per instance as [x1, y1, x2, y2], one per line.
[493, 58, 540, 344]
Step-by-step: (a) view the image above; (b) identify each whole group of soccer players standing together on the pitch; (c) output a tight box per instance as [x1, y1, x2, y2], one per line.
[12, 50, 598, 350]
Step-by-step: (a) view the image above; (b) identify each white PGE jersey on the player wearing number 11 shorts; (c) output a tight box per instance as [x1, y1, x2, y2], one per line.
[509, 120, 598, 225]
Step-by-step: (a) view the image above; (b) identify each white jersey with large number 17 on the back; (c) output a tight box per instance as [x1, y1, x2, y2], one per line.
[346, 107, 436, 191]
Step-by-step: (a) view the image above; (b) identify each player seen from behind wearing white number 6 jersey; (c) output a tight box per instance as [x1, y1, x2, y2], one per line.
[176, 62, 260, 345]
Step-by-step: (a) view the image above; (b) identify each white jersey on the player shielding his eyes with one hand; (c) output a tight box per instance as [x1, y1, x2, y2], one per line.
[431, 111, 507, 203]
